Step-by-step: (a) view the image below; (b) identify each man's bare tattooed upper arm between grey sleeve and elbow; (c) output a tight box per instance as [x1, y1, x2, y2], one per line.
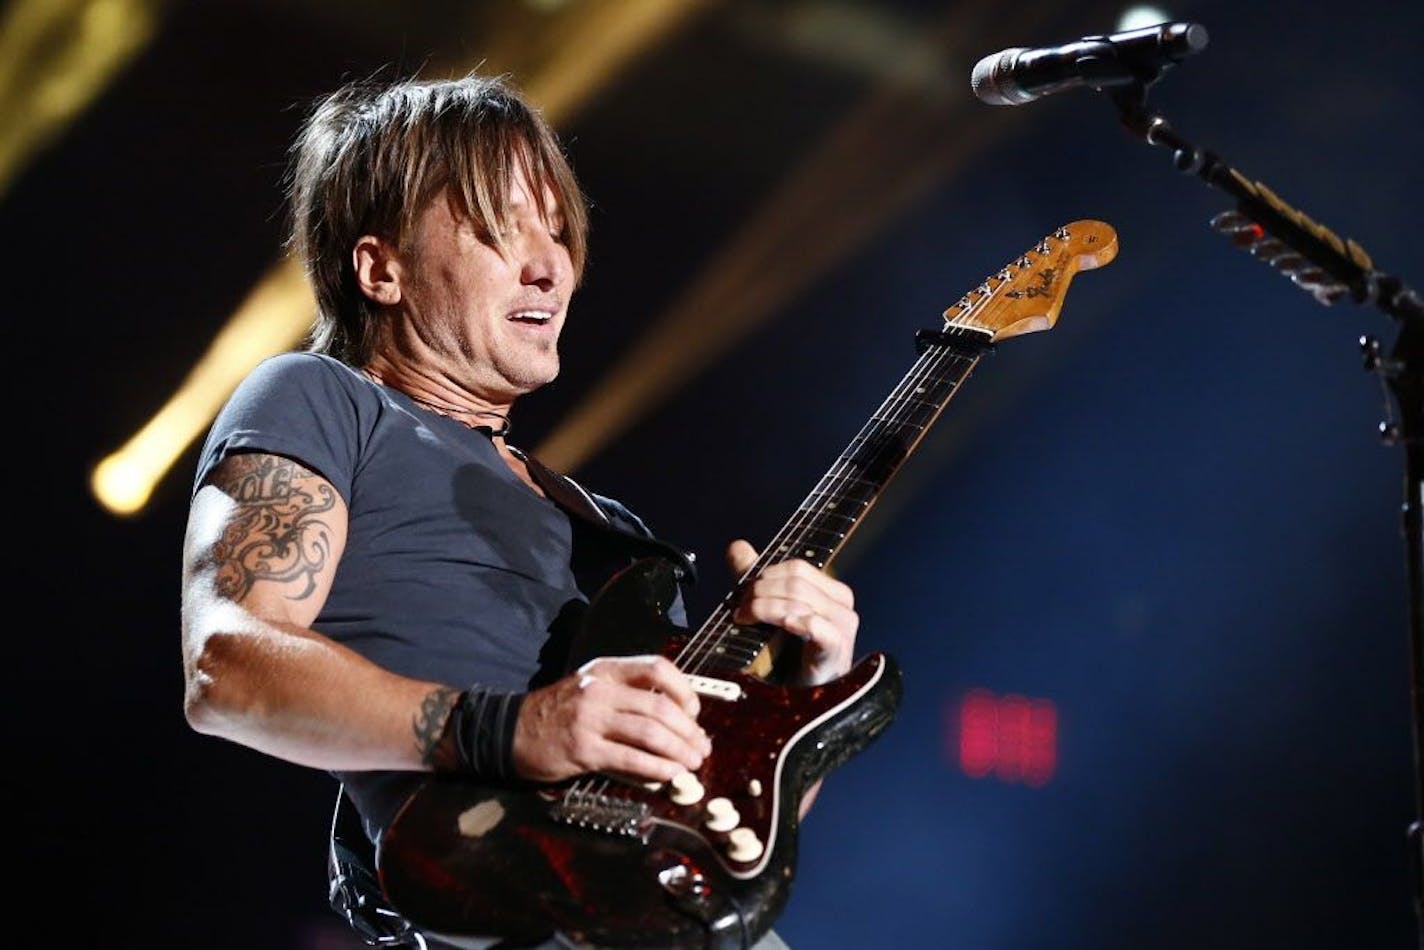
[184, 451, 347, 641]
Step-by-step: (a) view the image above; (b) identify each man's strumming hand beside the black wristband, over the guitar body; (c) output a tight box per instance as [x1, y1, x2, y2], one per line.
[514, 655, 712, 782]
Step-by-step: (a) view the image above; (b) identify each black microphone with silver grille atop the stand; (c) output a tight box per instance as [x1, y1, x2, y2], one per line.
[970, 23, 1206, 105]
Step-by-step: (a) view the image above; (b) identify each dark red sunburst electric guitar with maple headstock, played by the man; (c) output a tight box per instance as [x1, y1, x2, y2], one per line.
[376, 221, 1118, 949]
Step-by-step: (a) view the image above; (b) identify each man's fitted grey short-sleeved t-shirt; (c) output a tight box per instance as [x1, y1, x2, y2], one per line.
[194, 353, 685, 840]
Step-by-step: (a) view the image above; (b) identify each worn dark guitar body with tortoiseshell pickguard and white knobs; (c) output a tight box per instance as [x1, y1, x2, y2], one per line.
[377, 558, 900, 949]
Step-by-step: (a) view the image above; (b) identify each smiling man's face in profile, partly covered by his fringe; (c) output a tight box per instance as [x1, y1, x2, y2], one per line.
[402, 163, 574, 403]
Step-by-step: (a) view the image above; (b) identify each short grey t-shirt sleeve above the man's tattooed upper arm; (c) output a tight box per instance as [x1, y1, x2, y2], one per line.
[192, 353, 360, 503]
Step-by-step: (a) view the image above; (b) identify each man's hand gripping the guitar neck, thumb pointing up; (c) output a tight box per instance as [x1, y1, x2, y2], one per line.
[726, 538, 860, 687]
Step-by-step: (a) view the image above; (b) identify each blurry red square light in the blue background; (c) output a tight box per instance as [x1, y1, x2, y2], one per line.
[951, 689, 1058, 788]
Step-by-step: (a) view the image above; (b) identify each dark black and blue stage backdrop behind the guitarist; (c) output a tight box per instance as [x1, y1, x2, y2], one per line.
[13, 0, 1424, 950]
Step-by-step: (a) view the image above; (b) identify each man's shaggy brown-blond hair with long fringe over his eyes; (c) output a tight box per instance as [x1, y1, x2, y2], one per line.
[288, 75, 588, 366]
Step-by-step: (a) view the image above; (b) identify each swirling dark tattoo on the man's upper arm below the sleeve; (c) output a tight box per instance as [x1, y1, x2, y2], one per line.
[209, 453, 336, 601]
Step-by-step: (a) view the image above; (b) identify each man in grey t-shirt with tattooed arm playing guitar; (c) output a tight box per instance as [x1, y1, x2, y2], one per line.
[182, 77, 859, 946]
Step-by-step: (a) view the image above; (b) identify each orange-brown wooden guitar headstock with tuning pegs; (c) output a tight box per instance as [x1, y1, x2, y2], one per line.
[944, 221, 1118, 342]
